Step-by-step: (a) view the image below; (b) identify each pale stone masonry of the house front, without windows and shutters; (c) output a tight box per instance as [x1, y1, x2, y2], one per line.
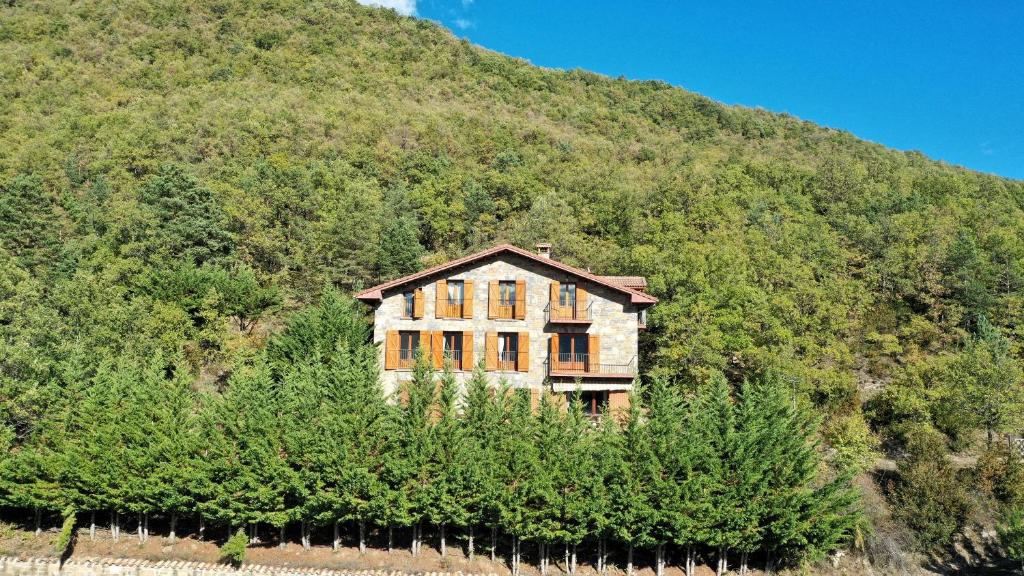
[374, 252, 643, 404]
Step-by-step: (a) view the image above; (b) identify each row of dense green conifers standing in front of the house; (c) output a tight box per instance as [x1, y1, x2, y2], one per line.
[0, 292, 860, 574]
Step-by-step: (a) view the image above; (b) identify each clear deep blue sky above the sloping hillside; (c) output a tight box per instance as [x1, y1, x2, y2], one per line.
[362, 0, 1024, 178]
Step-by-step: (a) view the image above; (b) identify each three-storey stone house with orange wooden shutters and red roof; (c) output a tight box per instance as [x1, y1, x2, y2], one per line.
[355, 244, 657, 414]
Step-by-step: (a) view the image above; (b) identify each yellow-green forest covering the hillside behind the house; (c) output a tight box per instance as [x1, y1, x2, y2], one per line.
[0, 0, 1024, 563]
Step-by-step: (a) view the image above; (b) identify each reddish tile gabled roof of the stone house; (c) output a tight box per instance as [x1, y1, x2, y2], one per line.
[355, 244, 657, 305]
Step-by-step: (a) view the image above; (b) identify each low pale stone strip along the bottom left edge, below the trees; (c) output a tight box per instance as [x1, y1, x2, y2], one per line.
[0, 557, 496, 576]
